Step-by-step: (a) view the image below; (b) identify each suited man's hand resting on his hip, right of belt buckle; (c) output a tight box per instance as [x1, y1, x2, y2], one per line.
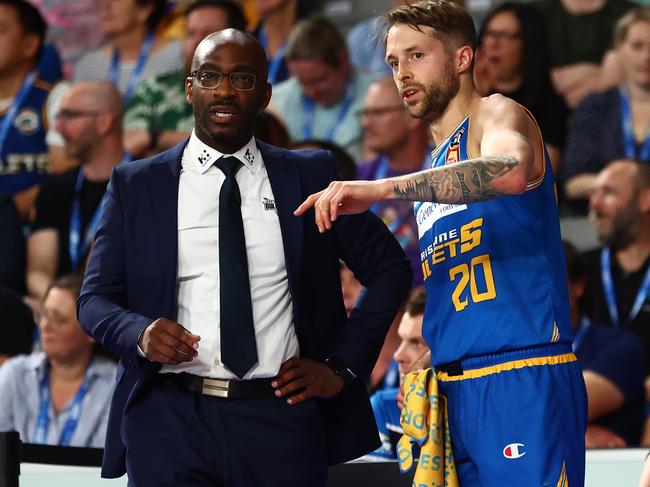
[271, 357, 343, 404]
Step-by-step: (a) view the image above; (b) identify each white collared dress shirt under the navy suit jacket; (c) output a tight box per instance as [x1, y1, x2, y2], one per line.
[161, 132, 298, 379]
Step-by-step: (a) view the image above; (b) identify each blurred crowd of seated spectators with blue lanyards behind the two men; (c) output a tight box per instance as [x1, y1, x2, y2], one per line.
[0, 0, 650, 456]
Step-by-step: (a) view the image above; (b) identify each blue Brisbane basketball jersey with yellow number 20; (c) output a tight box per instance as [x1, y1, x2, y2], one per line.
[415, 116, 572, 365]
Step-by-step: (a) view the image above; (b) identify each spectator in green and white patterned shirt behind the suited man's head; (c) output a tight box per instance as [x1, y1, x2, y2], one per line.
[124, 0, 246, 158]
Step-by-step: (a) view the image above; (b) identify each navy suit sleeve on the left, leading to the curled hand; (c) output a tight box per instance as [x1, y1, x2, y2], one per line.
[77, 168, 152, 362]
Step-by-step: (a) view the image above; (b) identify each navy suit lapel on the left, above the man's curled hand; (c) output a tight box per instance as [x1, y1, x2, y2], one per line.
[148, 141, 187, 319]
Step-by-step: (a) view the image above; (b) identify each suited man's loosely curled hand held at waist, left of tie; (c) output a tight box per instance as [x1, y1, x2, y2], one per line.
[138, 318, 201, 365]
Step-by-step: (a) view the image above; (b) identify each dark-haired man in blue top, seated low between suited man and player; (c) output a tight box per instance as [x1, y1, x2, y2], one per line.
[370, 288, 431, 459]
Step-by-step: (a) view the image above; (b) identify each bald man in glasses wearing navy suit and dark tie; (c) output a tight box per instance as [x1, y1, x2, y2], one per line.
[78, 29, 411, 487]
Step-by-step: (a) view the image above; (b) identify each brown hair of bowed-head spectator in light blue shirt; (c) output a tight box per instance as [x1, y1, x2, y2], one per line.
[285, 17, 347, 68]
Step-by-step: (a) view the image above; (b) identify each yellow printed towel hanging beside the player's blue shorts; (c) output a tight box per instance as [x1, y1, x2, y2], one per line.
[397, 369, 459, 487]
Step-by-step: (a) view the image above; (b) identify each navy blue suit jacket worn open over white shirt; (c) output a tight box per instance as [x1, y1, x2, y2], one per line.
[78, 141, 411, 477]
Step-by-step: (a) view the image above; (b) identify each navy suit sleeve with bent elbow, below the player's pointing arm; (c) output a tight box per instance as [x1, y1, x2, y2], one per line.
[334, 163, 412, 381]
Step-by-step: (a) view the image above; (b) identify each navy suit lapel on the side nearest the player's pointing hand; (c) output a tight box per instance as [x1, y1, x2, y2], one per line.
[257, 140, 303, 323]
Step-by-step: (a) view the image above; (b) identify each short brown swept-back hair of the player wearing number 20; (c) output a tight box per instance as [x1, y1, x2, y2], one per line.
[386, 0, 476, 49]
